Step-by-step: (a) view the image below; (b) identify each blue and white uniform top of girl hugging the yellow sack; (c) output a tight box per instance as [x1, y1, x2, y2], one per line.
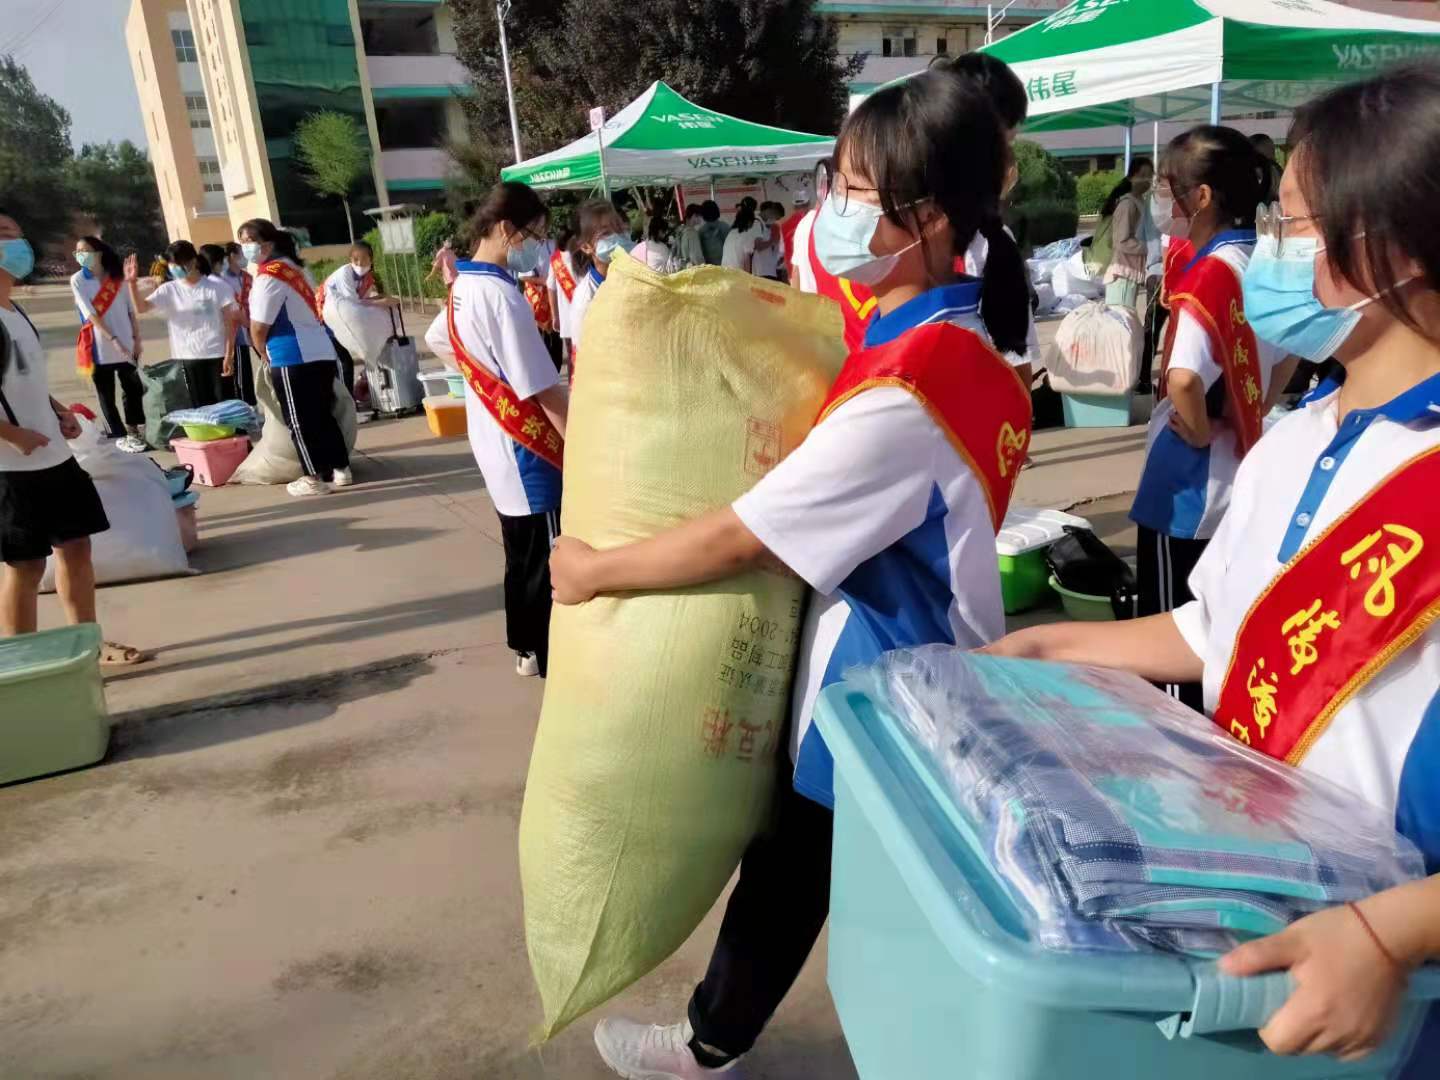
[733, 281, 1005, 806]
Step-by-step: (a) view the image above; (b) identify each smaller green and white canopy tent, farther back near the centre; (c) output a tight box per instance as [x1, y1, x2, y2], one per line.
[501, 82, 835, 189]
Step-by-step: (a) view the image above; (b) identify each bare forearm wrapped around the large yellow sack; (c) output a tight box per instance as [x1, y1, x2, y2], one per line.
[550, 507, 766, 603]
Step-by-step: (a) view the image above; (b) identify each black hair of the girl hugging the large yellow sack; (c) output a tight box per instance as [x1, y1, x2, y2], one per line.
[835, 68, 1030, 353]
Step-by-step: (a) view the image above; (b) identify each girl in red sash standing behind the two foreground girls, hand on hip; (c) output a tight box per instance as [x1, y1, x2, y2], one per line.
[1130, 127, 1283, 708]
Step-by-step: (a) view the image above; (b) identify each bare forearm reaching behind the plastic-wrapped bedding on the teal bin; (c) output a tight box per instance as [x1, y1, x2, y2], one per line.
[981, 612, 1205, 683]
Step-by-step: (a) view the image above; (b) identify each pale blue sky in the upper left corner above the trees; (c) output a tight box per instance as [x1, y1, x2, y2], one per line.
[0, 0, 145, 148]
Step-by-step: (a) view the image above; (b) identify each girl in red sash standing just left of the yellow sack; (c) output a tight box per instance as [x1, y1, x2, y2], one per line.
[425, 183, 570, 677]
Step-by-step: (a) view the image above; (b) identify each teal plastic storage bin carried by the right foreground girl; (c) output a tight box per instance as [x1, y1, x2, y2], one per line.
[816, 683, 1440, 1080]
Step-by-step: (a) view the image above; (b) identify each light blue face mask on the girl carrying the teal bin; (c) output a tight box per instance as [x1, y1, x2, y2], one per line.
[1243, 236, 1371, 361]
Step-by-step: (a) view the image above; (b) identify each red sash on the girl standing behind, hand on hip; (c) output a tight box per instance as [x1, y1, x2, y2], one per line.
[1159, 256, 1264, 458]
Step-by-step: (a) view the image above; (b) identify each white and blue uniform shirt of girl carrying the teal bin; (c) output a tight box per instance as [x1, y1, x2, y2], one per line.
[1171, 376, 1440, 873]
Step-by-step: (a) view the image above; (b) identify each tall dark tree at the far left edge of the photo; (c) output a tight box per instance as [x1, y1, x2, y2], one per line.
[0, 56, 73, 249]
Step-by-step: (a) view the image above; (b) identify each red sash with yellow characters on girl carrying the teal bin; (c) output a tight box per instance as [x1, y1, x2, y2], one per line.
[1215, 446, 1440, 765]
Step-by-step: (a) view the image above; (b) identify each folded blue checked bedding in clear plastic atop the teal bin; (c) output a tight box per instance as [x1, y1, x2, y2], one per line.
[847, 647, 1424, 956]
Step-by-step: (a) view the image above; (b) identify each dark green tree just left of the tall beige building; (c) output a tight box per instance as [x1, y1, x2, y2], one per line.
[71, 140, 166, 258]
